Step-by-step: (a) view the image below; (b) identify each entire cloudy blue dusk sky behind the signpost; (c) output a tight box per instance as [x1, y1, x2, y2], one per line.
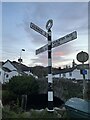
[0, 2, 88, 67]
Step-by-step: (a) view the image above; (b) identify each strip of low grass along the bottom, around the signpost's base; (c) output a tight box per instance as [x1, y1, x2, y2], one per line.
[2, 106, 67, 120]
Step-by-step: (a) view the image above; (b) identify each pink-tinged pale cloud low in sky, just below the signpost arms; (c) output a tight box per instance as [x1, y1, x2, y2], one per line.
[32, 40, 75, 67]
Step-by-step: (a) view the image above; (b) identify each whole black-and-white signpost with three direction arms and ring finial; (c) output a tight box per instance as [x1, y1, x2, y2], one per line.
[30, 19, 77, 112]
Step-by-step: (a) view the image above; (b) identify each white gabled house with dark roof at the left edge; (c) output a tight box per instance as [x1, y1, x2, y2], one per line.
[0, 60, 38, 83]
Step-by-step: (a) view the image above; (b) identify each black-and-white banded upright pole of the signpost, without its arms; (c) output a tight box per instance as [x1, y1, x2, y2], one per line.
[48, 29, 53, 111]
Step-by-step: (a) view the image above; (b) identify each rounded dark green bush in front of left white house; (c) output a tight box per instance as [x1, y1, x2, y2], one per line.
[8, 76, 39, 95]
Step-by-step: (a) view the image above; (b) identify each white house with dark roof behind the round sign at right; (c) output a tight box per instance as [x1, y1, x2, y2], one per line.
[53, 64, 90, 80]
